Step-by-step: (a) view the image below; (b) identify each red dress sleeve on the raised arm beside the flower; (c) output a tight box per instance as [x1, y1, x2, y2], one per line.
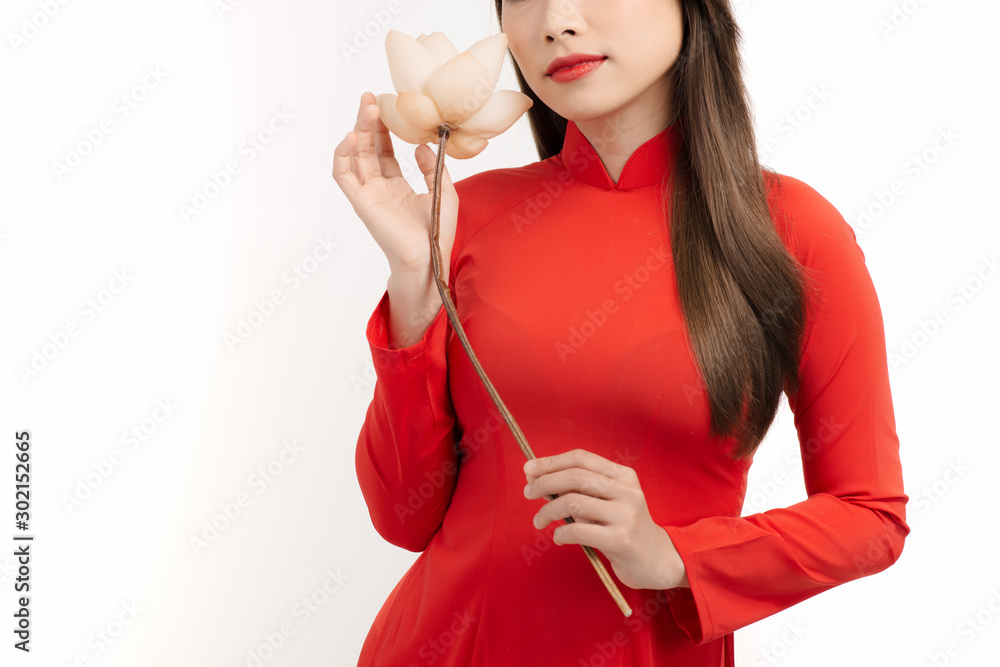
[355, 290, 458, 551]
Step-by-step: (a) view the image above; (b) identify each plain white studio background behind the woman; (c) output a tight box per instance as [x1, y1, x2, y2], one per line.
[0, 0, 1000, 667]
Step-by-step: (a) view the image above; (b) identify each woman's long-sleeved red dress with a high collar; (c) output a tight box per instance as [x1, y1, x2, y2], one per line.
[356, 122, 910, 667]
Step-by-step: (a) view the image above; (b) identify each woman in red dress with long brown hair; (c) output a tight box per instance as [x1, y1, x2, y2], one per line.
[334, 0, 909, 667]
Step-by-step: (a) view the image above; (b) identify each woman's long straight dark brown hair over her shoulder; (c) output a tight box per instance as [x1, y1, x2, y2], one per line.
[495, 0, 809, 460]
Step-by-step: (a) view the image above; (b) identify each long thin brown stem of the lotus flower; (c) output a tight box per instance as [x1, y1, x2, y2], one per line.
[431, 123, 632, 617]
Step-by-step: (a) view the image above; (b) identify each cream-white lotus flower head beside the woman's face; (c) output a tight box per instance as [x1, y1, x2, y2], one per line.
[375, 30, 532, 160]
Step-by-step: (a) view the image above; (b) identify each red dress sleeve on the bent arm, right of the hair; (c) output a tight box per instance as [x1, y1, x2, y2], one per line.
[664, 176, 910, 644]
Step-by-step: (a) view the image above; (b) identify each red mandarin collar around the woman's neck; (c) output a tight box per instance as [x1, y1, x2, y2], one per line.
[559, 121, 680, 190]
